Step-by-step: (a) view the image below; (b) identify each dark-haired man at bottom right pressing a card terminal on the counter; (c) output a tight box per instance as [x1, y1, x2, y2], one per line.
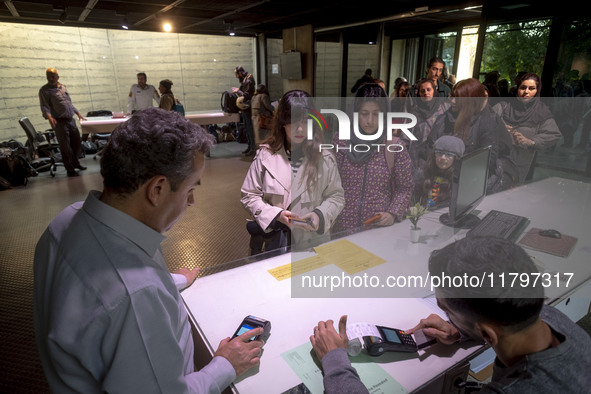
[310, 237, 591, 394]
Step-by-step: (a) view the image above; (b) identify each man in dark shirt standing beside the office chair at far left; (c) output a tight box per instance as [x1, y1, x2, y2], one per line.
[39, 68, 86, 176]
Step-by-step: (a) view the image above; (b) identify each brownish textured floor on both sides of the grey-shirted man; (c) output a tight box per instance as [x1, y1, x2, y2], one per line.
[0, 142, 252, 393]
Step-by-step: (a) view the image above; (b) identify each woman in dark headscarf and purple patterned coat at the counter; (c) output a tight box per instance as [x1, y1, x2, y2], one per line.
[333, 83, 414, 233]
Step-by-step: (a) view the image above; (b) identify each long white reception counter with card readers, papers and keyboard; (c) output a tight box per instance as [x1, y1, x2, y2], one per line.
[182, 178, 591, 393]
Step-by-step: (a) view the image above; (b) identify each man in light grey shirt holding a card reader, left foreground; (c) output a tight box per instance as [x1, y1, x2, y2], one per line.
[34, 108, 262, 393]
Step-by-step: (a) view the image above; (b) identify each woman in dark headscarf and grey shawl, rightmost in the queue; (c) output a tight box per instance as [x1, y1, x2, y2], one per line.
[493, 73, 562, 183]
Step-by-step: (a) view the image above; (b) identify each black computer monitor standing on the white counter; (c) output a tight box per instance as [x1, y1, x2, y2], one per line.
[439, 145, 491, 228]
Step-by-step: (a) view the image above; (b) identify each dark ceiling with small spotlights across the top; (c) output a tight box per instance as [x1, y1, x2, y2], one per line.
[0, 0, 484, 36]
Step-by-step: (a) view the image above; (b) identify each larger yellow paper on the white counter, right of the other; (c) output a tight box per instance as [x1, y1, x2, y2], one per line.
[314, 239, 386, 275]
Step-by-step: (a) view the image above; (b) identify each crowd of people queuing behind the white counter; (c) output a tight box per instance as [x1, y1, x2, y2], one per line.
[242, 58, 561, 254]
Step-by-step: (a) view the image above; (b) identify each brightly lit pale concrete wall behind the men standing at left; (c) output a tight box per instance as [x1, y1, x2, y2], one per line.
[0, 23, 256, 142]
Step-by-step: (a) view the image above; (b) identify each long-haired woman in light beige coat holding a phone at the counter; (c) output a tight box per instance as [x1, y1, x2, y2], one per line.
[241, 90, 345, 254]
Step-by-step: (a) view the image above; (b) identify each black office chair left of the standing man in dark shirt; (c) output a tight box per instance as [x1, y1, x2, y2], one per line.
[18, 116, 64, 177]
